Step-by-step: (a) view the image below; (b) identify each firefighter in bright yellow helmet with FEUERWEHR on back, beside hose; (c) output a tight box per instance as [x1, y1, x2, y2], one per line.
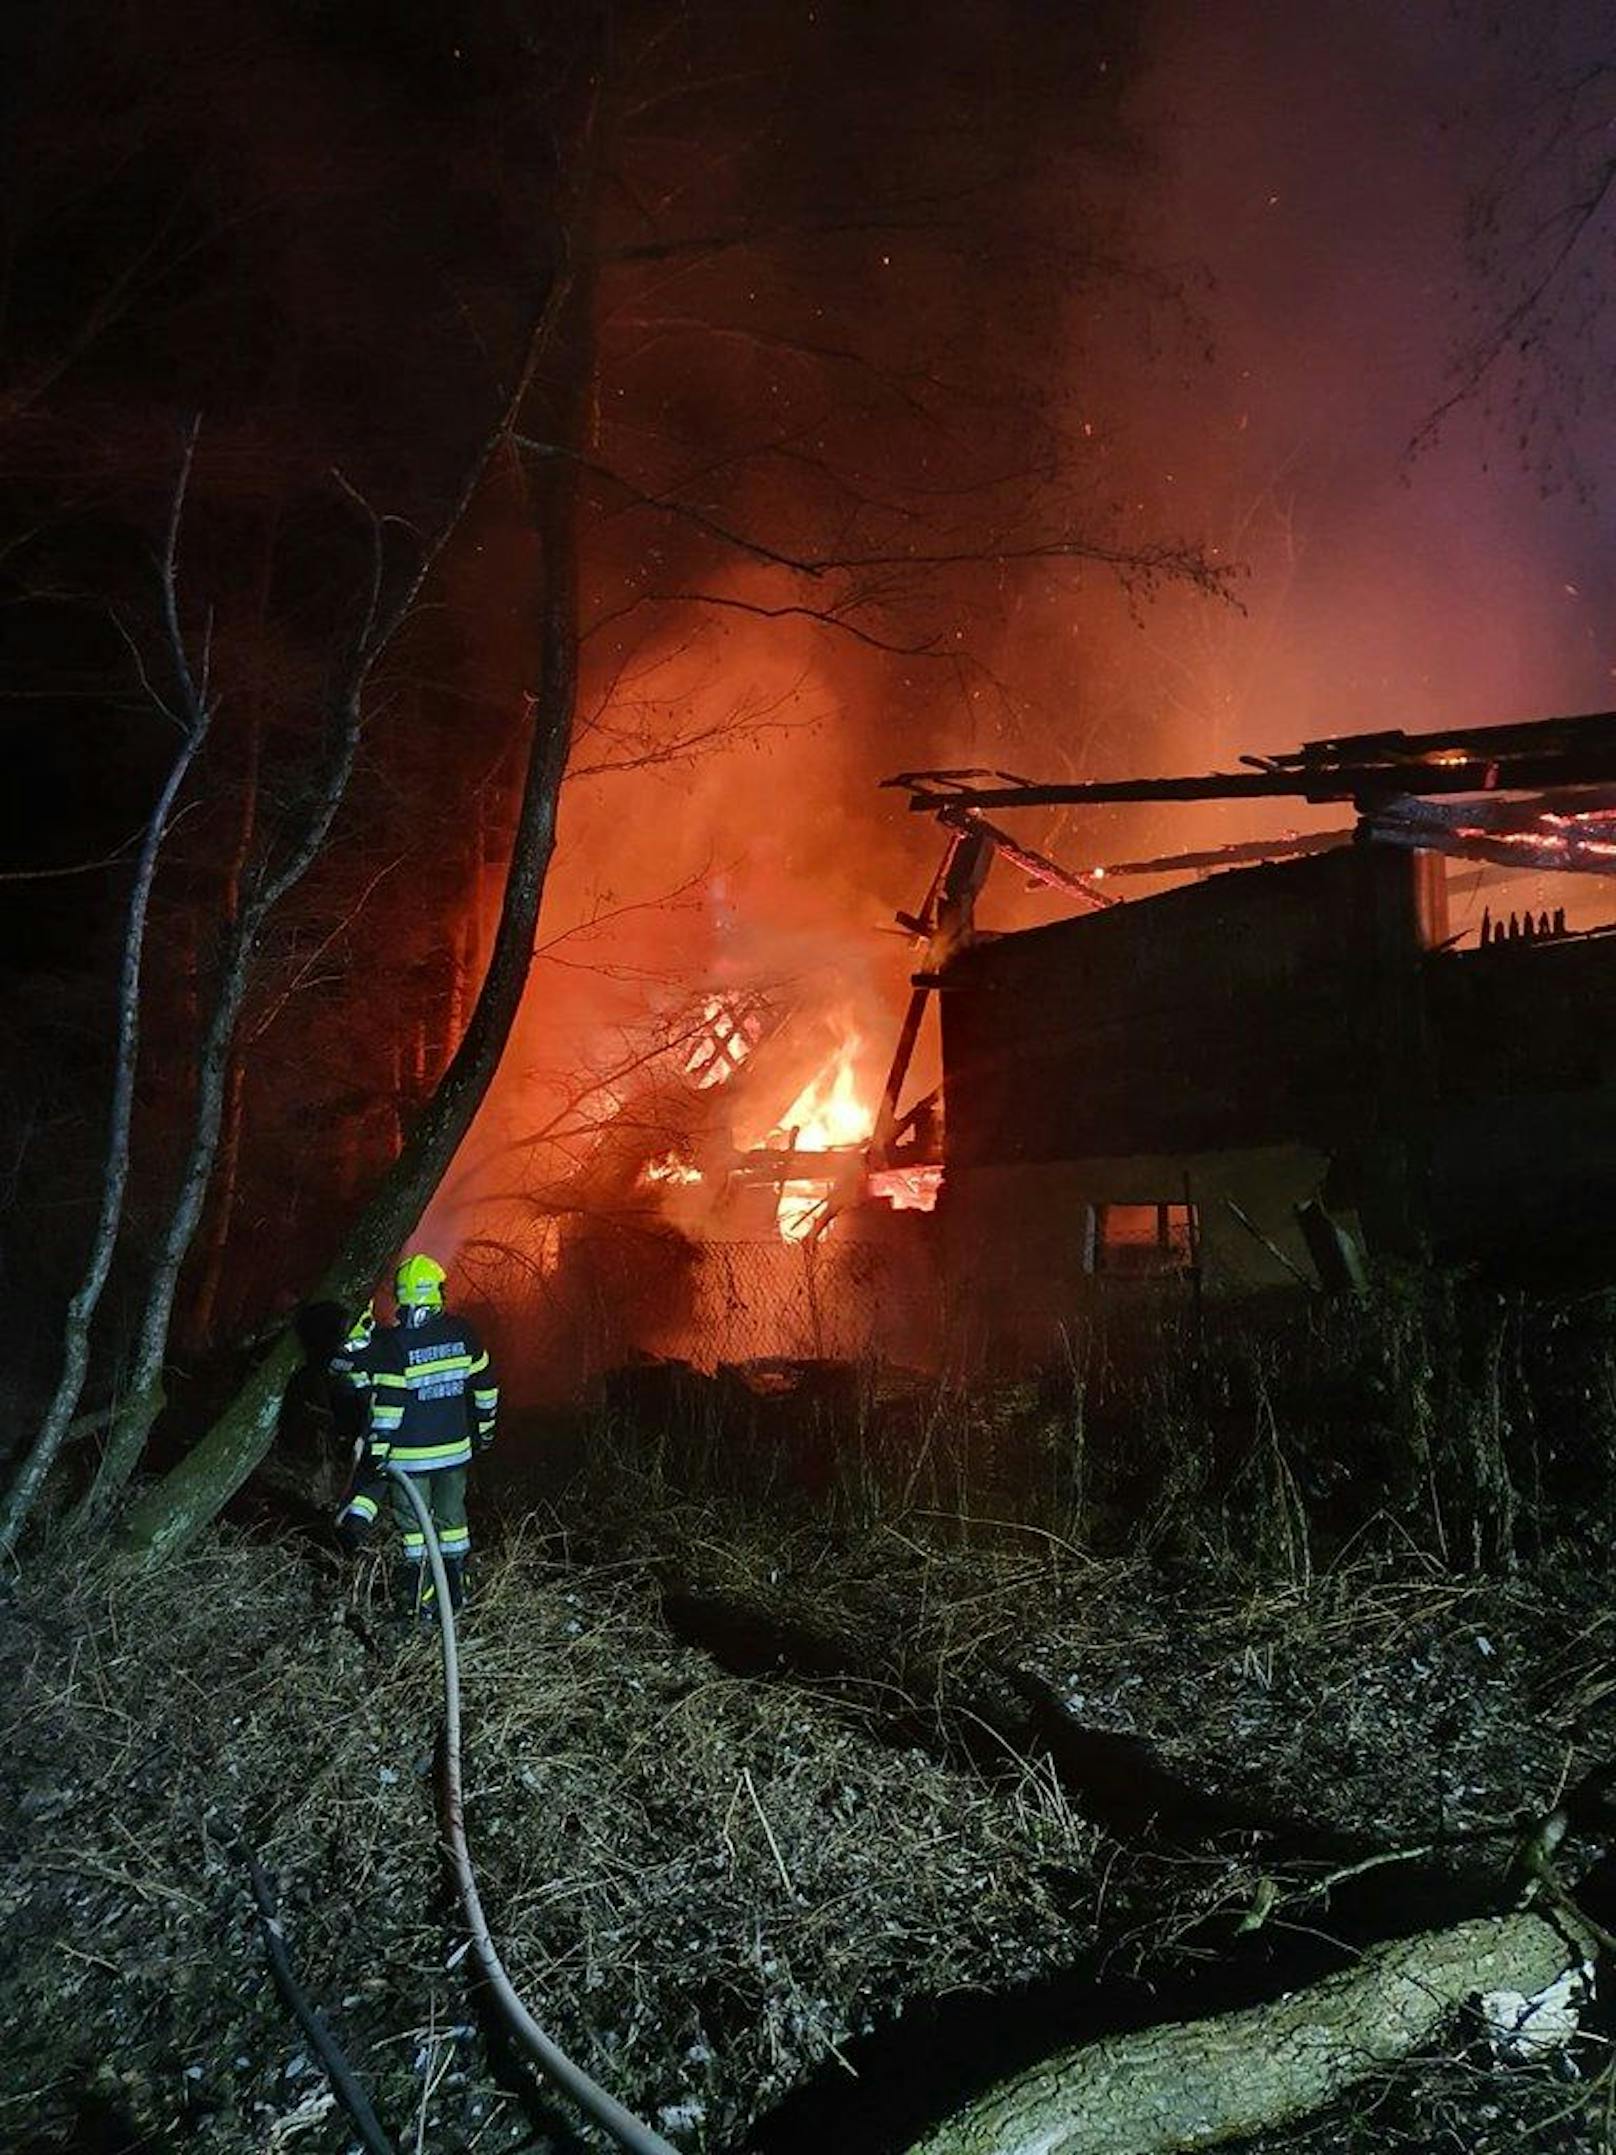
[336, 1252, 500, 1618]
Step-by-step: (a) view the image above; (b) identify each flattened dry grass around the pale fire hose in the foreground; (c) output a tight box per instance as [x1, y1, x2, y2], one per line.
[0, 1541, 1097, 2151]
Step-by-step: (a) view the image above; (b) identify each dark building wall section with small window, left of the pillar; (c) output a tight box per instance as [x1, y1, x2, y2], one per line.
[937, 847, 1446, 1347]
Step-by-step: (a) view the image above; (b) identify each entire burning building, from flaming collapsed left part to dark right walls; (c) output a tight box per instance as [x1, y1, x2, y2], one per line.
[471, 718, 1616, 1377]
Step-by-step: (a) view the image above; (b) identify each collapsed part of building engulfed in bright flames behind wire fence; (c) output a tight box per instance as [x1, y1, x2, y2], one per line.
[459, 978, 942, 1396]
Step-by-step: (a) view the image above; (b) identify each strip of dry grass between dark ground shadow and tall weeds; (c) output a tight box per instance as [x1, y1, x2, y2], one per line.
[564, 1459, 1616, 1843]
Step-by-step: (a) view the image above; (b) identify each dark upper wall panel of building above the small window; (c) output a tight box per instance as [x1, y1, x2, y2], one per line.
[939, 847, 1435, 1168]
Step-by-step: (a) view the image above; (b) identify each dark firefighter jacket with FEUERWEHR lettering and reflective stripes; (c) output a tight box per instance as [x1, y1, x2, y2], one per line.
[366, 1310, 500, 1474]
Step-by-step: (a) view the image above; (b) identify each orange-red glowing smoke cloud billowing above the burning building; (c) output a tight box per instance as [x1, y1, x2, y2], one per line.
[431, 0, 1616, 1379]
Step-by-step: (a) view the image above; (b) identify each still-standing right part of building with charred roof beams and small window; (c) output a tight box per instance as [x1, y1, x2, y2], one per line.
[909, 718, 1616, 1358]
